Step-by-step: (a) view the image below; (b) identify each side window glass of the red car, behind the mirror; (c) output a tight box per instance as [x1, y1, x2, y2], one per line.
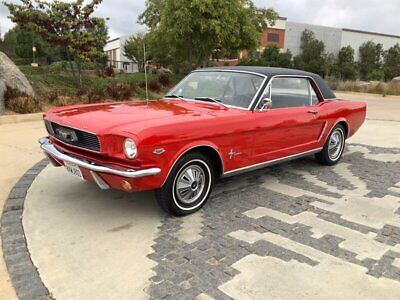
[271, 78, 318, 109]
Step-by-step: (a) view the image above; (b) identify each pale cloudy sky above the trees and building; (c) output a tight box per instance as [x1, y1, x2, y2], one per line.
[0, 0, 400, 38]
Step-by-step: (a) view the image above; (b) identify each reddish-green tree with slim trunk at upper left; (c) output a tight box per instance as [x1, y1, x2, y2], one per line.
[4, 0, 107, 88]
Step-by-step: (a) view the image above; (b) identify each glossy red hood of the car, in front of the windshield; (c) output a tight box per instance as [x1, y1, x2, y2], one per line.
[45, 99, 225, 135]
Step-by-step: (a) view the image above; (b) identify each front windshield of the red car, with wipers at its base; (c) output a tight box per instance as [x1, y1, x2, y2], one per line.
[167, 71, 264, 108]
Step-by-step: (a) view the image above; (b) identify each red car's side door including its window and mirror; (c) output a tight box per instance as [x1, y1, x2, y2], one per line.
[253, 77, 325, 163]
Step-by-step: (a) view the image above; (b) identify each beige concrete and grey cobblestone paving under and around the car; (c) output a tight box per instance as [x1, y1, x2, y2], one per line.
[0, 95, 400, 299]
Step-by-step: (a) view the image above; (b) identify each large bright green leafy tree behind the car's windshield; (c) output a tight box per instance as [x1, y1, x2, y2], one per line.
[139, 0, 277, 69]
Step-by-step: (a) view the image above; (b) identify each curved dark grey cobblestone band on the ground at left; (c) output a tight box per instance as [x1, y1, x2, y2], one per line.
[0, 159, 52, 300]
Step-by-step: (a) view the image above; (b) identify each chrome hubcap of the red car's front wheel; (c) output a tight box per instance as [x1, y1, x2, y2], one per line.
[175, 165, 205, 204]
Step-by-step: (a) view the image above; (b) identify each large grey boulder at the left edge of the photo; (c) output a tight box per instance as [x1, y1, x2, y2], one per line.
[0, 52, 35, 115]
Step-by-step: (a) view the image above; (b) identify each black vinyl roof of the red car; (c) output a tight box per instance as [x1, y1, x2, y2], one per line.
[197, 66, 336, 99]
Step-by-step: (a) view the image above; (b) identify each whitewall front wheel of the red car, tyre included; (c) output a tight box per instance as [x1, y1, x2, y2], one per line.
[156, 153, 215, 216]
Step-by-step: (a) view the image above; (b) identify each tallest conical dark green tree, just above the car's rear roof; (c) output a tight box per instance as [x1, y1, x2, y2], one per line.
[294, 29, 330, 76]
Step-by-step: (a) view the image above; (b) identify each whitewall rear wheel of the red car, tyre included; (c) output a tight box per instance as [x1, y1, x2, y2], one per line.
[315, 125, 346, 166]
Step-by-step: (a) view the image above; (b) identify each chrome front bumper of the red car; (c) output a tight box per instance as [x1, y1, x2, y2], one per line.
[39, 138, 161, 178]
